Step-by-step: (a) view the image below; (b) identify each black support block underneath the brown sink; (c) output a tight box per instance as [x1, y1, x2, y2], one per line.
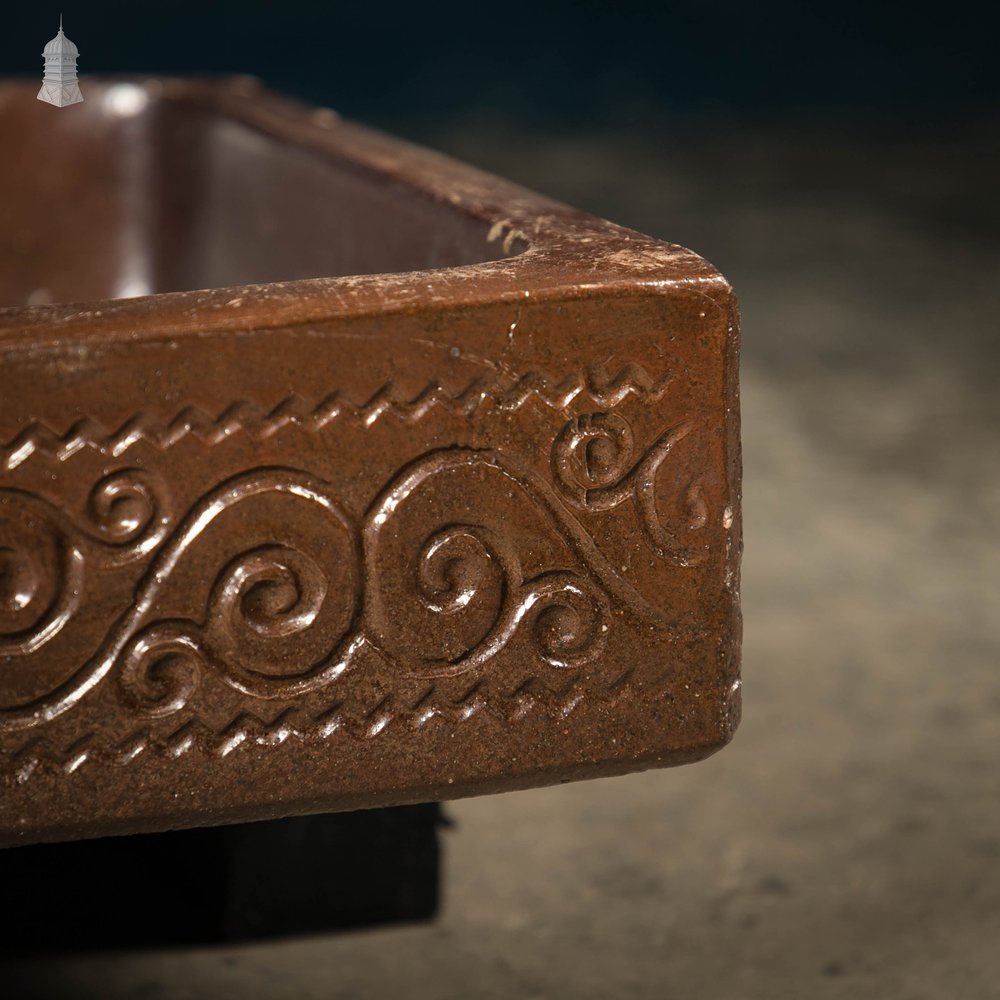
[0, 804, 442, 955]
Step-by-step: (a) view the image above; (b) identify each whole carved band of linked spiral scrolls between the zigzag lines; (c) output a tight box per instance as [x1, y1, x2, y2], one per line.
[0, 394, 705, 763]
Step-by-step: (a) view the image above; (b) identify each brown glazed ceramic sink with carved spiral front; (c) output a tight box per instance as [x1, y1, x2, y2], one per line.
[0, 79, 741, 844]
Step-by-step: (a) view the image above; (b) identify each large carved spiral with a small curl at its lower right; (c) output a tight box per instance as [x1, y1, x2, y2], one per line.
[364, 449, 607, 677]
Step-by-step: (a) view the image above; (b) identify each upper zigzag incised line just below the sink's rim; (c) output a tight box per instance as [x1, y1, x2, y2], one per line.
[0, 363, 672, 471]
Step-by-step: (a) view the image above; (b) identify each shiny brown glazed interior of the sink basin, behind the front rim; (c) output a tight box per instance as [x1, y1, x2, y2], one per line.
[0, 79, 503, 307]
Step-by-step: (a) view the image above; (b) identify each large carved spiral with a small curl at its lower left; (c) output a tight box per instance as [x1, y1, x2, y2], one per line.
[109, 470, 361, 714]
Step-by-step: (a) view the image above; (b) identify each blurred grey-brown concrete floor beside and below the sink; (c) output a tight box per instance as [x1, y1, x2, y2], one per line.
[8, 115, 1000, 1000]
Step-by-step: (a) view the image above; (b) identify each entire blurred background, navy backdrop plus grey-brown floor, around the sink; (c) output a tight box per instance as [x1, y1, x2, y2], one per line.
[0, 0, 1000, 1000]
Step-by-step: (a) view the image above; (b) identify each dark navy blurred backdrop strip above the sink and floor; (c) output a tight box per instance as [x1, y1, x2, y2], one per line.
[0, 0, 1000, 127]
